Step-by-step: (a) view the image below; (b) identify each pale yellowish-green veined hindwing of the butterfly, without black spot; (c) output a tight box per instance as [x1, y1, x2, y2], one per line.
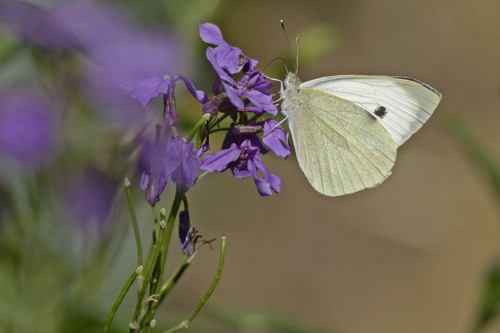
[288, 89, 397, 196]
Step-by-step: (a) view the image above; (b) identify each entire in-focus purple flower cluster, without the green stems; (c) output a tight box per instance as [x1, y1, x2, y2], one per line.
[122, 23, 290, 204]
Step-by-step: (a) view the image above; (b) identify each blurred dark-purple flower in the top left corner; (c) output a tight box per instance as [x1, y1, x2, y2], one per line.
[0, 0, 82, 50]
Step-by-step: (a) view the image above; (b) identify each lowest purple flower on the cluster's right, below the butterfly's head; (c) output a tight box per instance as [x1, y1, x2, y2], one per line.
[200, 139, 281, 196]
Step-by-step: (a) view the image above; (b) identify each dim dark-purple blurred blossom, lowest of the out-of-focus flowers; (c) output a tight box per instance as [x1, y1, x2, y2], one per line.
[64, 169, 117, 232]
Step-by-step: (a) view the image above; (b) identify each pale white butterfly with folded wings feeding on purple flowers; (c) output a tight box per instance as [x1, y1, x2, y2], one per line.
[280, 73, 441, 196]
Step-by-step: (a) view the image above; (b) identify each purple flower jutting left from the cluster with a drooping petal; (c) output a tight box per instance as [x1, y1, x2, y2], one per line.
[121, 75, 207, 126]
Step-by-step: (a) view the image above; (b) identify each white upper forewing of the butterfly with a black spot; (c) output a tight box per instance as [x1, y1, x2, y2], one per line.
[300, 75, 441, 146]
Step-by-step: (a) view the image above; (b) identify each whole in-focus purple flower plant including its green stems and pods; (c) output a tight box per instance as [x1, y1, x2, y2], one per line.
[106, 23, 290, 333]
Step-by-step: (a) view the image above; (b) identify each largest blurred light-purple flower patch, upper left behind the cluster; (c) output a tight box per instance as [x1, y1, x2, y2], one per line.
[55, 1, 186, 124]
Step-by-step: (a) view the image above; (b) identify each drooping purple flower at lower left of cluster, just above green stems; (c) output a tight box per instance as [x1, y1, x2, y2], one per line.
[140, 131, 199, 205]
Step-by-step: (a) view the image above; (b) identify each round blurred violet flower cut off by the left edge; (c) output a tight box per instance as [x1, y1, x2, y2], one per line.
[0, 90, 57, 166]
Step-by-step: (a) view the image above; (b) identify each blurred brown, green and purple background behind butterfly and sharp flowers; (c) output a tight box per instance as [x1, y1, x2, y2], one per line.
[0, 0, 500, 333]
